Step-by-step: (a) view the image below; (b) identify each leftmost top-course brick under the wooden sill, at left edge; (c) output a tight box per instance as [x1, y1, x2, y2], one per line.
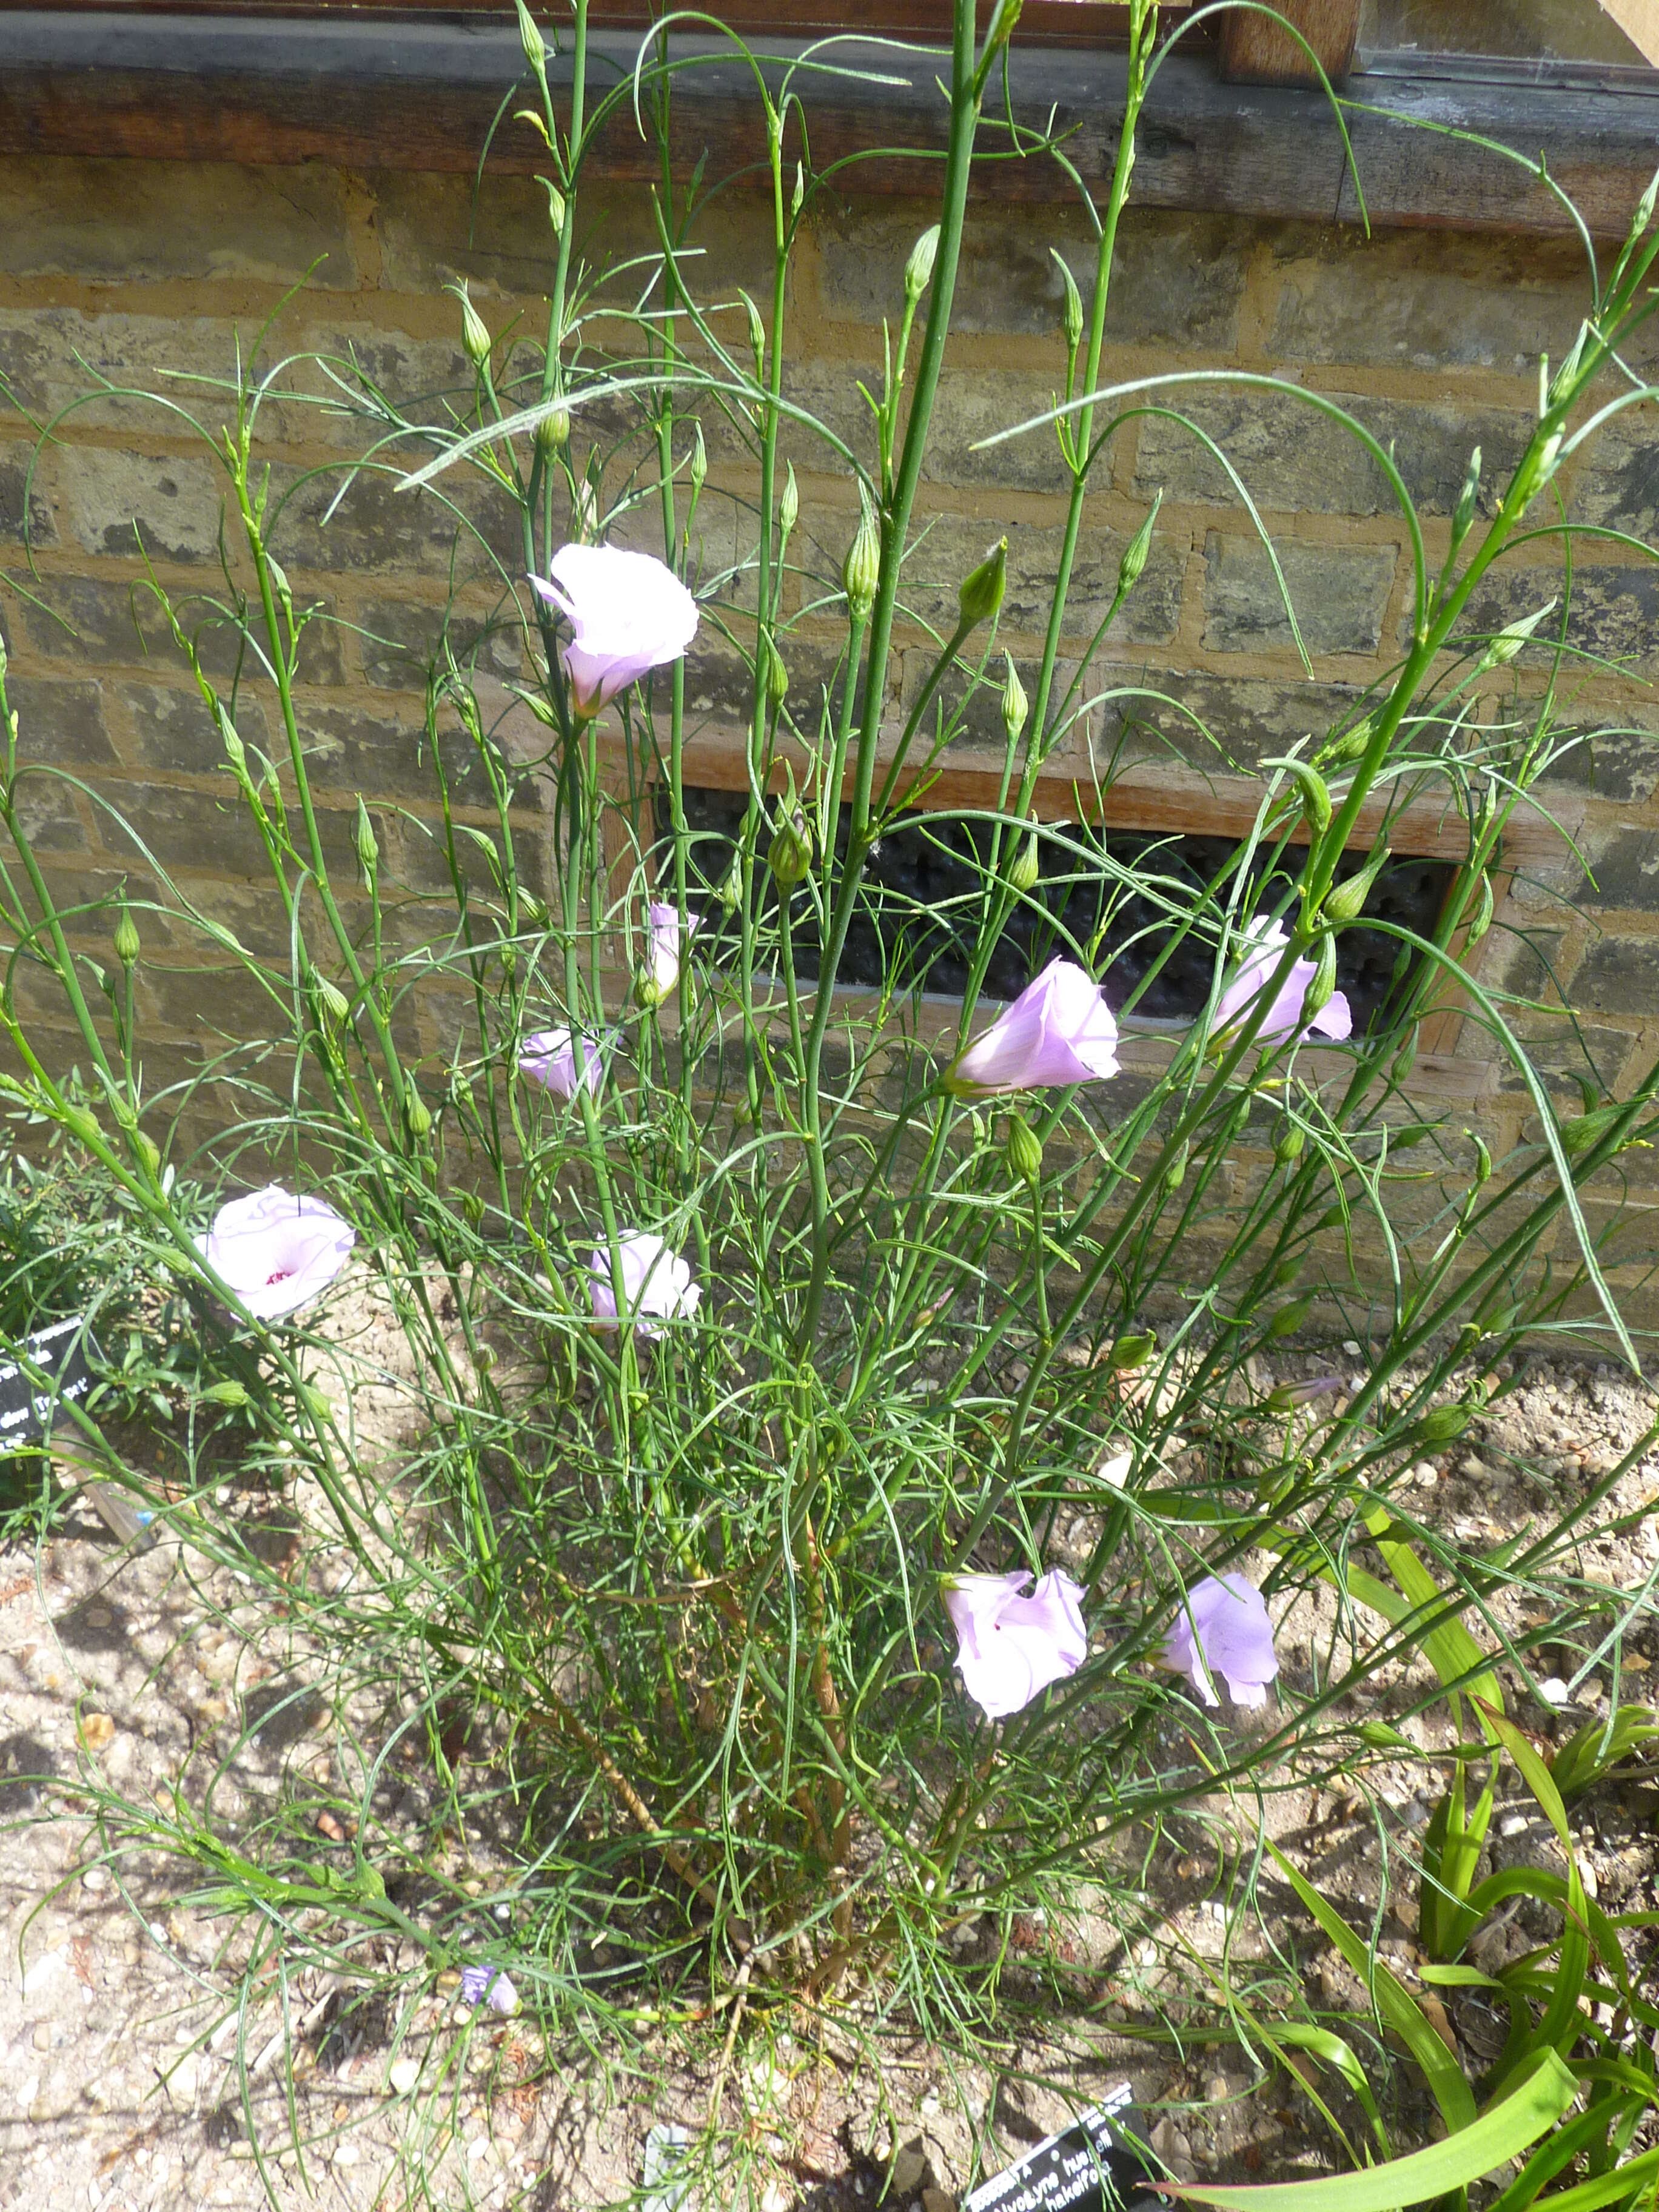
[0, 153, 361, 290]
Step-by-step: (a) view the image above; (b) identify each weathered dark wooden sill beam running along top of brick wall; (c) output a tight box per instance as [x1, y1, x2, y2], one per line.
[0, 9, 1659, 239]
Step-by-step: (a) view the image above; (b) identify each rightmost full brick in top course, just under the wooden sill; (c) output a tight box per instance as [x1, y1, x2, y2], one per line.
[1267, 228, 1586, 376]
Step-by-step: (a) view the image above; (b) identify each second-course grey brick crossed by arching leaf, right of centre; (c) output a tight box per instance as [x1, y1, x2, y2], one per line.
[1134, 392, 1533, 515]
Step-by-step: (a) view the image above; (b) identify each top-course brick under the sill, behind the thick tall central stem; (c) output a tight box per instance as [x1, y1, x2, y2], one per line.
[816, 204, 1250, 352]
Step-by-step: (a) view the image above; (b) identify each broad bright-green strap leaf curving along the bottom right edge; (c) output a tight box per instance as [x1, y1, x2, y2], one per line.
[1159, 2043, 1575, 2212]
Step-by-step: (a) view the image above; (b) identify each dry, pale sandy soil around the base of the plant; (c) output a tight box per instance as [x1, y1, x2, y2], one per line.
[0, 1361, 1659, 2212]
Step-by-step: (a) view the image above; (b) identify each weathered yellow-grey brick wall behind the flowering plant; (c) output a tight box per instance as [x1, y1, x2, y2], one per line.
[0, 159, 1659, 1309]
